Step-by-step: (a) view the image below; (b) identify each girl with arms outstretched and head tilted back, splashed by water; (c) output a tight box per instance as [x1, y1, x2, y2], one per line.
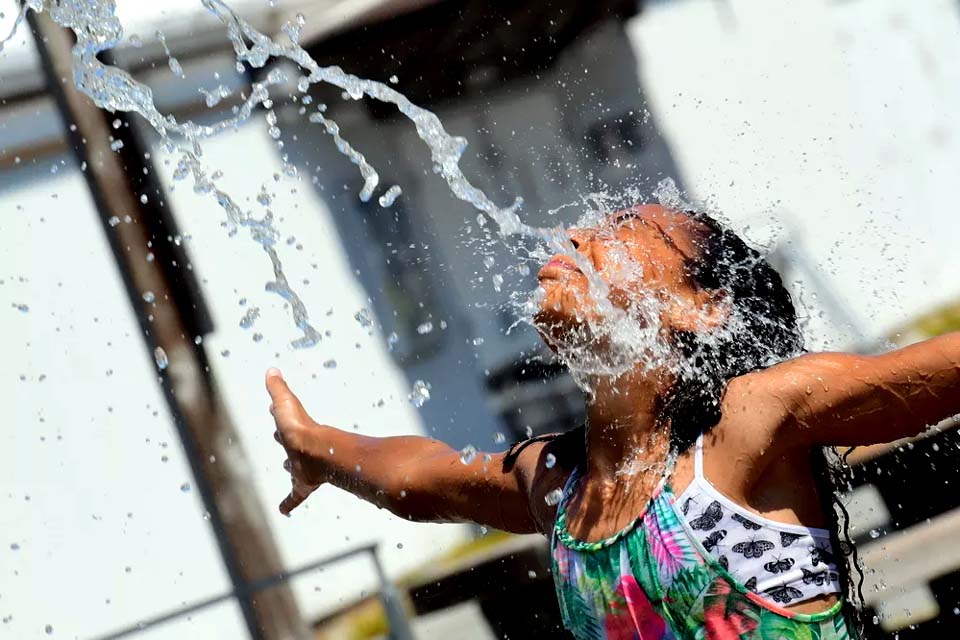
[267, 205, 960, 640]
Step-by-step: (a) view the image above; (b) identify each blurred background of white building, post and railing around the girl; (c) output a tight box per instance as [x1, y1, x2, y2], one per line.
[0, 0, 960, 639]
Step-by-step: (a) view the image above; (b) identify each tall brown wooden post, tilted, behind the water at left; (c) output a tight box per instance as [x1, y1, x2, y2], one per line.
[28, 11, 309, 640]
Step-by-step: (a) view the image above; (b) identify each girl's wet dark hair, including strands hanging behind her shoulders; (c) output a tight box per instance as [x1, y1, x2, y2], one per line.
[505, 211, 873, 638]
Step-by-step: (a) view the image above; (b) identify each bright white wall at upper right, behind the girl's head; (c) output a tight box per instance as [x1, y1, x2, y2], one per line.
[630, 0, 960, 344]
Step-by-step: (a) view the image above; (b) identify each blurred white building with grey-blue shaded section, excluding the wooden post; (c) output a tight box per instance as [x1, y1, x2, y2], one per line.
[0, 0, 960, 637]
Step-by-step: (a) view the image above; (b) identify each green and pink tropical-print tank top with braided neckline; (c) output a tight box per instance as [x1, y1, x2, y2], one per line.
[552, 472, 855, 640]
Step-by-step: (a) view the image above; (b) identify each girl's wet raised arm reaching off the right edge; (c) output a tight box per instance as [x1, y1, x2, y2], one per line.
[768, 332, 960, 446]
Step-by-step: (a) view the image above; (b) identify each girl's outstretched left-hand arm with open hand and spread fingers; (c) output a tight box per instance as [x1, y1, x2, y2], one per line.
[267, 369, 558, 533]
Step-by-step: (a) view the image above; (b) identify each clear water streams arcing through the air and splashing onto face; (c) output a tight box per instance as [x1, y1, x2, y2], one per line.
[11, 0, 712, 390]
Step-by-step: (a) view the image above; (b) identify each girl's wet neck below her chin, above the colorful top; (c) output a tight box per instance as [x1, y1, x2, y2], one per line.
[586, 372, 670, 485]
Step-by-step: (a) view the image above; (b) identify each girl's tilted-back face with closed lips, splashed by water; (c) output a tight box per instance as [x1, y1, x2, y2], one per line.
[534, 205, 710, 346]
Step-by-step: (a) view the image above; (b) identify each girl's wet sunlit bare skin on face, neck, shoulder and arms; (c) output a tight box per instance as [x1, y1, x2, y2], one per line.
[267, 205, 960, 613]
